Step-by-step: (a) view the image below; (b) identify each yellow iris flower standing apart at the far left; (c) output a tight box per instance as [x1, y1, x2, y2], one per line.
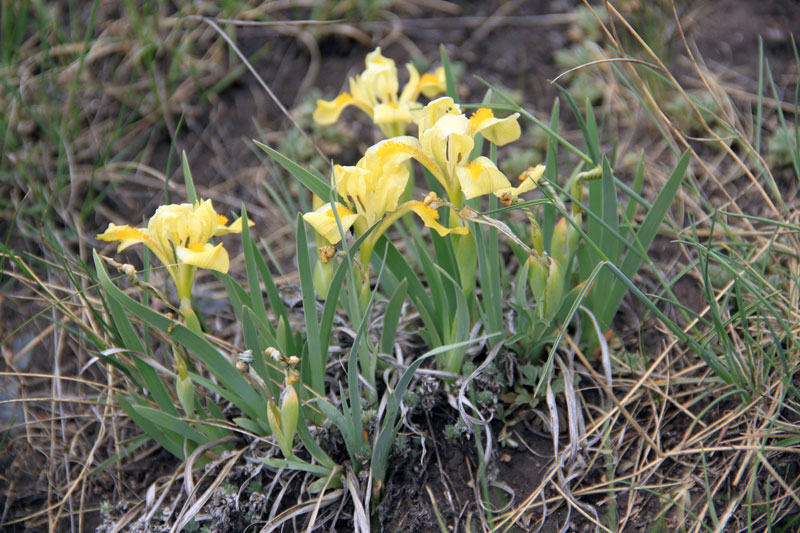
[97, 200, 252, 301]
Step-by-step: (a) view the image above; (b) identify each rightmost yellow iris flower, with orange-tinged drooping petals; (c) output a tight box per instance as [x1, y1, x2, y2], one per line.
[367, 96, 520, 207]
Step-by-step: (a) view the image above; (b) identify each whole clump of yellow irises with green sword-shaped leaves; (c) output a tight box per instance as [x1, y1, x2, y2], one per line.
[94, 43, 687, 519]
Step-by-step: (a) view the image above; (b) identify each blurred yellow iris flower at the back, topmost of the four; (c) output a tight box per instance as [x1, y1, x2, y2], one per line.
[314, 47, 445, 137]
